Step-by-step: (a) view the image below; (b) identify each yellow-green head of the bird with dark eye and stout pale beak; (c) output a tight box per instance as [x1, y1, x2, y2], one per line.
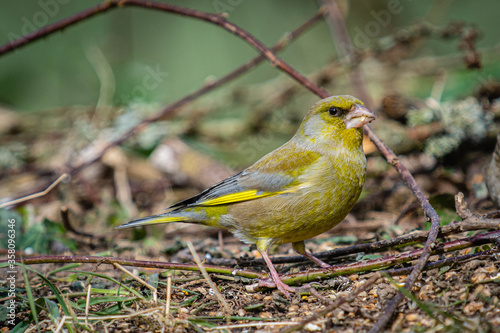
[297, 95, 376, 144]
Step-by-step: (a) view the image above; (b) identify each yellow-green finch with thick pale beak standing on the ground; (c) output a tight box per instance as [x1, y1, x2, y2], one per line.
[117, 95, 376, 298]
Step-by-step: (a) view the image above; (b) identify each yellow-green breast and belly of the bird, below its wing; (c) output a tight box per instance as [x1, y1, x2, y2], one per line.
[225, 150, 366, 244]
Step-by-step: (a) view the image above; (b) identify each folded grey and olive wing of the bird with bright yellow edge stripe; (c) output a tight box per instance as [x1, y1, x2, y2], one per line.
[168, 149, 320, 210]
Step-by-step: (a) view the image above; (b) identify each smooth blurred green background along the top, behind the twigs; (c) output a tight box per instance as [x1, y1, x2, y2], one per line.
[0, 0, 500, 111]
